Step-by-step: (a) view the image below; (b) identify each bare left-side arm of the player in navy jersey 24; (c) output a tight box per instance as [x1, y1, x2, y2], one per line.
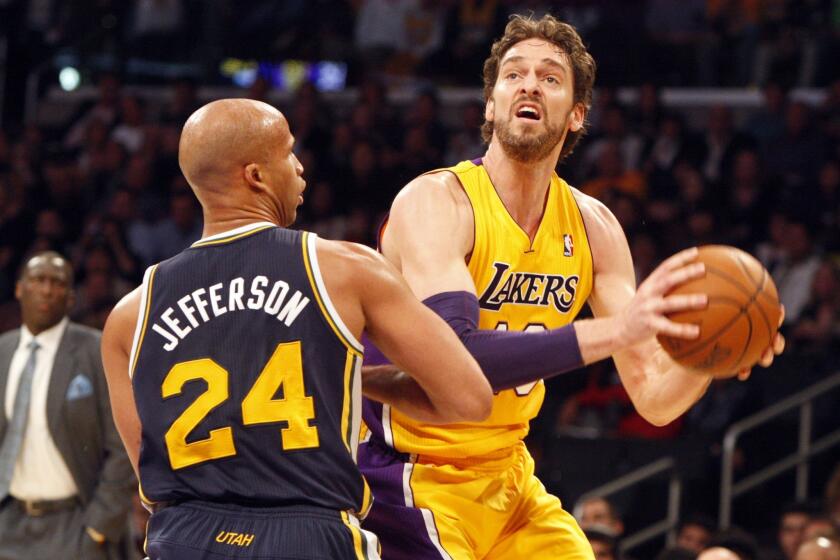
[102, 288, 141, 476]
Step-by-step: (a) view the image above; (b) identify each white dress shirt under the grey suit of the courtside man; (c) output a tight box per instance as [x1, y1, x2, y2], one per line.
[5, 317, 78, 500]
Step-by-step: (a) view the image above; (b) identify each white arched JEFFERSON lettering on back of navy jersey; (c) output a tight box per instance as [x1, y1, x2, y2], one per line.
[152, 275, 309, 352]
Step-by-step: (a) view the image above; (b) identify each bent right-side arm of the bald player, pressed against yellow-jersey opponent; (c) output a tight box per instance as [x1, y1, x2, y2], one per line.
[318, 239, 492, 422]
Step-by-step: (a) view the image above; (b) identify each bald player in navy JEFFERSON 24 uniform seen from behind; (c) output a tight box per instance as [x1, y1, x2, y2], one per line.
[102, 99, 491, 560]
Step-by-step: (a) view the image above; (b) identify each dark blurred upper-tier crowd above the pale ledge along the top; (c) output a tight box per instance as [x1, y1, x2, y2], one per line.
[0, 0, 840, 94]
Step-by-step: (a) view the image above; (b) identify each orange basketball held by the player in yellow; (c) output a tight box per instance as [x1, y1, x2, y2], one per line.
[657, 245, 781, 377]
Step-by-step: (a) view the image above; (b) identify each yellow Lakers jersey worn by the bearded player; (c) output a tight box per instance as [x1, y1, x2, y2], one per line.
[382, 161, 593, 458]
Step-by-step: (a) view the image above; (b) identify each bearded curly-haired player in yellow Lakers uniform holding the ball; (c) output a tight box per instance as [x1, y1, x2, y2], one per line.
[359, 12, 783, 560]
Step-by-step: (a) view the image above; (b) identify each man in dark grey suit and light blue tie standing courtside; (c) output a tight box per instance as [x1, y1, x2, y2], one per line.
[0, 252, 135, 560]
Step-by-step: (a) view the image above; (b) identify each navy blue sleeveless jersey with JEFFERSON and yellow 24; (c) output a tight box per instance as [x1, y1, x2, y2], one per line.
[130, 223, 370, 514]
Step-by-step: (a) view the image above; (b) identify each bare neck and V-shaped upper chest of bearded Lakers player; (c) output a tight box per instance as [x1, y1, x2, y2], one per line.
[483, 138, 562, 239]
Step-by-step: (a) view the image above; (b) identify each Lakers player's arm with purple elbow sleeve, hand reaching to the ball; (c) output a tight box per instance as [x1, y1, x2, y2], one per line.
[382, 172, 705, 390]
